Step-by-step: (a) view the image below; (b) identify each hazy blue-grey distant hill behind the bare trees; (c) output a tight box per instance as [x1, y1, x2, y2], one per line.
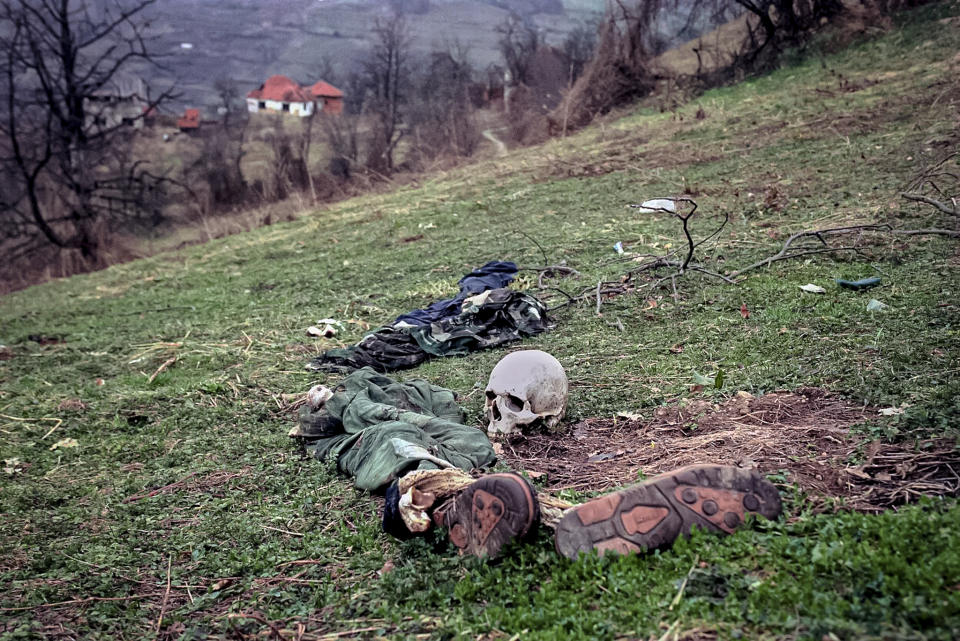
[130, 0, 605, 109]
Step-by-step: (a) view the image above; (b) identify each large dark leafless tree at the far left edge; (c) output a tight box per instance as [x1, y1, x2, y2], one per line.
[0, 0, 169, 261]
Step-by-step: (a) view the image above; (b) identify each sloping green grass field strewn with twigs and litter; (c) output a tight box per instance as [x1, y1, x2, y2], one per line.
[0, 1, 960, 639]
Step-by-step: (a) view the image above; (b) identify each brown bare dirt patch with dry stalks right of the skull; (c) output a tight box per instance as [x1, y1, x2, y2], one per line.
[503, 388, 960, 512]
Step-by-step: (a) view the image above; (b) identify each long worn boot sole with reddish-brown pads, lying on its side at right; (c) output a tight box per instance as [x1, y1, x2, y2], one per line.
[556, 465, 780, 559]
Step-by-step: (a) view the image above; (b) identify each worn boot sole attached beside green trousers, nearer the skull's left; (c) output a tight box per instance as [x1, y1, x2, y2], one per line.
[440, 473, 540, 559]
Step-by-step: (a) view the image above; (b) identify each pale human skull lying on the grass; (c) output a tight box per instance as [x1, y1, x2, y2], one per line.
[486, 349, 567, 436]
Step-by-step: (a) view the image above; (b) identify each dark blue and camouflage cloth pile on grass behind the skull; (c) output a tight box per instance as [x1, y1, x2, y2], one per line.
[307, 261, 553, 373]
